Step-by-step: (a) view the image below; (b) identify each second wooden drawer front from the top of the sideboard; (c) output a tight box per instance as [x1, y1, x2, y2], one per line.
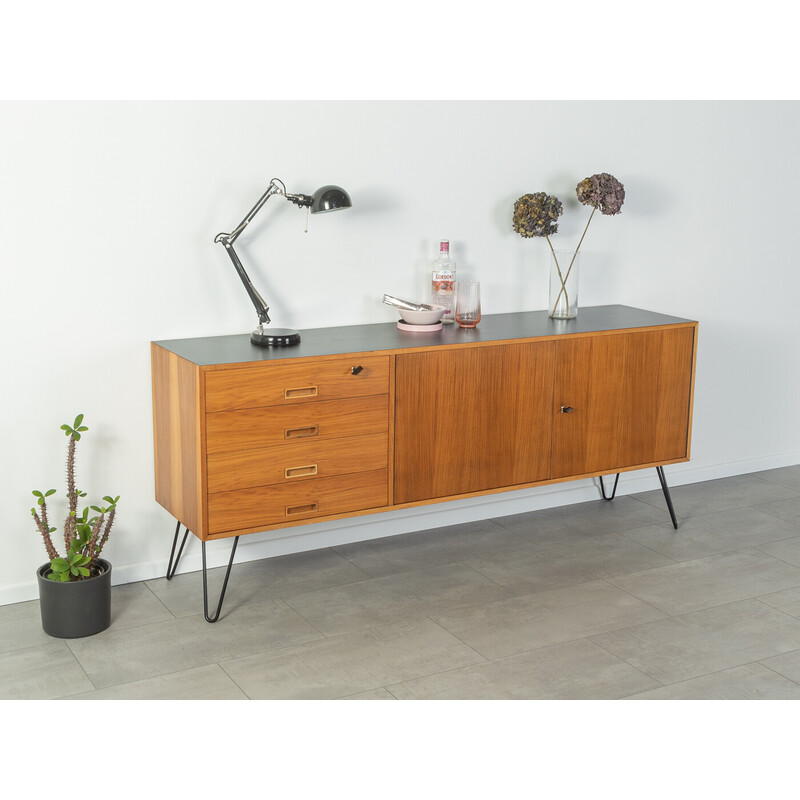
[206, 395, 389, 454]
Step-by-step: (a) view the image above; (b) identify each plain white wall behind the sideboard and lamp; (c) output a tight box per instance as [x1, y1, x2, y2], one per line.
[0, 101, 800, 602]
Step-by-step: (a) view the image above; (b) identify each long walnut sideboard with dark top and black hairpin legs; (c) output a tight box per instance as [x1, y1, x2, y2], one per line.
[151, 306, 698, 622]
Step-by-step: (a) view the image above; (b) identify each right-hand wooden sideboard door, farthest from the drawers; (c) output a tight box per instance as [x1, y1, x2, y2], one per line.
[551, 327, 695, 478]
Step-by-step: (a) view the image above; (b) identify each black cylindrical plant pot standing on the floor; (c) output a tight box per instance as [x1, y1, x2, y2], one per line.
[36, 558, 111, 639]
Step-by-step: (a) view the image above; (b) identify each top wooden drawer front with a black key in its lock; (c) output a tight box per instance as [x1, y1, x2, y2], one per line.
[205, 356, 389, 412]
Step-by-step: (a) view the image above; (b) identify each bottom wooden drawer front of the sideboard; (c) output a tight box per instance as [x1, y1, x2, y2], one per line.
[208, 470, 389, 535]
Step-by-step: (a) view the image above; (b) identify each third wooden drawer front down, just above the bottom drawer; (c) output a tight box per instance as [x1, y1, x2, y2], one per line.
[208, 433, 389, 492]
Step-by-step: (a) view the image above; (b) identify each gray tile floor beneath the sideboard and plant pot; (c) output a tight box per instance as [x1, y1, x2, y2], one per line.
[0, 465, 800, 700]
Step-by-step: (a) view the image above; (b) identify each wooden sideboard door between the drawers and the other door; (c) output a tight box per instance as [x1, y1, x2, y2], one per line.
[394, 342, 554, 504]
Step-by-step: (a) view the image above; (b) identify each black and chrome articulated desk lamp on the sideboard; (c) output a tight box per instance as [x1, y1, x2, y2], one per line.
[214, 178, 352, 347]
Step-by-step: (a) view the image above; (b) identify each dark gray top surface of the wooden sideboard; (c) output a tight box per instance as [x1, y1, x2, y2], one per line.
[155, 306, 692, 367]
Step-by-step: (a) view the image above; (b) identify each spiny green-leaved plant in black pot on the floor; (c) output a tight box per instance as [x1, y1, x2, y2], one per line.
[31, 414, 119, 639]
